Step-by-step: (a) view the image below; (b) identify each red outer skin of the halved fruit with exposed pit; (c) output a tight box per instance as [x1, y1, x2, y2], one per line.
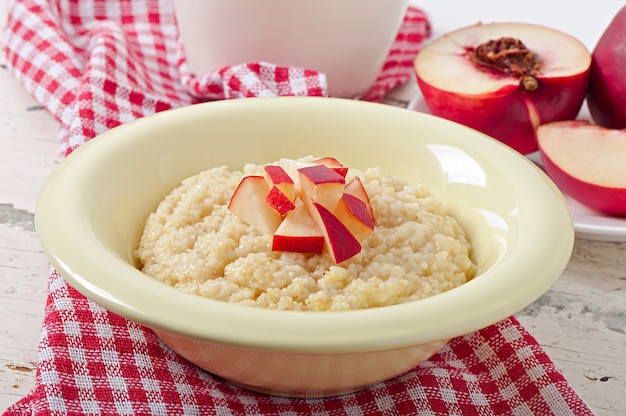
[417, 69, 589, 154]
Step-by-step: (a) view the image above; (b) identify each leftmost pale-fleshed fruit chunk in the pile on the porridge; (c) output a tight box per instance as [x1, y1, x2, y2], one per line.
[228, 175, 282, 235]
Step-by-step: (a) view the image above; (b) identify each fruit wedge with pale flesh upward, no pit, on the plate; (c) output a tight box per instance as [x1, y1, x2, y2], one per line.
[537, 120, 626, 216]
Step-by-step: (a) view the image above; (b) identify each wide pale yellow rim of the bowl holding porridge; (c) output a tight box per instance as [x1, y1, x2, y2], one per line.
[35, 97, 574, 353]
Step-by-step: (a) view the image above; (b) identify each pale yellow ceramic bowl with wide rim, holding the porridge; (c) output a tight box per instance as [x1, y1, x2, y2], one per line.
[35, 97, 574, 397]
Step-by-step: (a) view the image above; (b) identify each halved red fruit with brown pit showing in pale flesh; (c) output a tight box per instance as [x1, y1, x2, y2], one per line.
[415, 23, 591, 154]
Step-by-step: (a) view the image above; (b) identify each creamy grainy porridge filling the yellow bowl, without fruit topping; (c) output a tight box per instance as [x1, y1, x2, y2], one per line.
[136, 158, 476, 311]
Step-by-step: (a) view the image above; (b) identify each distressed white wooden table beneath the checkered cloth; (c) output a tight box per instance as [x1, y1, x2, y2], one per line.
[0, 0, 626, 416]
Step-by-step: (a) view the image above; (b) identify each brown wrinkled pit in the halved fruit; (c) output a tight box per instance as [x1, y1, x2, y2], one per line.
[468, 37, 541, 91]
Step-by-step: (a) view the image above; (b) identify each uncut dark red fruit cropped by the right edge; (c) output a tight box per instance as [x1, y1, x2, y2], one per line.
[587, 6, 626, 129]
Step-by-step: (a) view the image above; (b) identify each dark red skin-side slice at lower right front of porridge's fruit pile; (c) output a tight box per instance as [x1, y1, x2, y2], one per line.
[312, 202, 361, 264]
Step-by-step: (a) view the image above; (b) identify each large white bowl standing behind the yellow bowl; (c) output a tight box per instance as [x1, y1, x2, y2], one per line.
[174, 0, 408, 98]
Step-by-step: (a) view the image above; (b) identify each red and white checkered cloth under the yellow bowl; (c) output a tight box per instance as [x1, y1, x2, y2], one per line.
[5, 0, 592, 416]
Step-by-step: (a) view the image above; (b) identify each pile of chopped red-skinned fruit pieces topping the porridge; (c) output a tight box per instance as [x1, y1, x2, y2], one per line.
[228, 157, 374, 263]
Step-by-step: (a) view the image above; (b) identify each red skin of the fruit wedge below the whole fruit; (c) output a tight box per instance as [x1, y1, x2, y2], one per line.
[540, 152, 626, 217]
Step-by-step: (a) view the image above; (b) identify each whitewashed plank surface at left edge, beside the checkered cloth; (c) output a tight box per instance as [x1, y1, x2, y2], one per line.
[0, 0, 59, 410]
